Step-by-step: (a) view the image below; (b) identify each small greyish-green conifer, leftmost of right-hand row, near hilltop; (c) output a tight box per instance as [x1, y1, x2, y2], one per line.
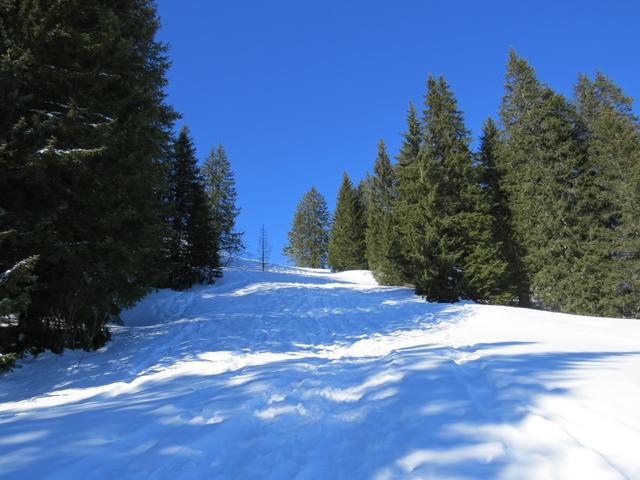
[283, 187, 331, 268]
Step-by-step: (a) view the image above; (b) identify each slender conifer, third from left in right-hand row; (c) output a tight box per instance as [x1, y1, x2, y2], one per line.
[366, 140, 402, 285]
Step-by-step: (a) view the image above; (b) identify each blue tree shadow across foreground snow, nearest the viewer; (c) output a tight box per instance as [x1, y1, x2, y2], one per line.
[0, 342, 640, 479]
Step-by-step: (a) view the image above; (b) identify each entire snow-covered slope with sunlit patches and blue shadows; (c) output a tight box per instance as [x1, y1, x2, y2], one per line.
[0, 261, 640, 480]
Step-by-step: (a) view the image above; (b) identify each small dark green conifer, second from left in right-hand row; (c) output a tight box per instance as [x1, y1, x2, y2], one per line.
[327, 173, 367, 272]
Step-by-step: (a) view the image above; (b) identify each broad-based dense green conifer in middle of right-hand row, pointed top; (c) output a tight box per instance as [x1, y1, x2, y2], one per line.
[397, 77, 506, 301]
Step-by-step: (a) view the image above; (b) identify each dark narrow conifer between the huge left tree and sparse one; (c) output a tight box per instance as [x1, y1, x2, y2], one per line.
[168, 127, 220, 290]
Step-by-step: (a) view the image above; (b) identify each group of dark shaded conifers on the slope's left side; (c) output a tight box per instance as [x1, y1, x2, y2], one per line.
[0, 0, 241, 360]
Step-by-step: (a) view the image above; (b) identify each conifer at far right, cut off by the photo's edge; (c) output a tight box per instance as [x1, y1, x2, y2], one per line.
[575, 73, 640, 317]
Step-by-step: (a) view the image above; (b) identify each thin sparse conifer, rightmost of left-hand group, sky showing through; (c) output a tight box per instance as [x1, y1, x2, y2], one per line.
[202, 145, 244, 264]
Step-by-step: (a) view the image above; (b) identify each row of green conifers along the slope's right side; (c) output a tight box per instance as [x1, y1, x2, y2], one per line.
[285, 52, 640, 317]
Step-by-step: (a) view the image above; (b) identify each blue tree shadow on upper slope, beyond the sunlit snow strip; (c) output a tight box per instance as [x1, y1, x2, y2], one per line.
[0, 282, 465, 401]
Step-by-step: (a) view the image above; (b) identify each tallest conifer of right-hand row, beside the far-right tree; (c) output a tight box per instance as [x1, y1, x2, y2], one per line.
[500, 52, 597, 313]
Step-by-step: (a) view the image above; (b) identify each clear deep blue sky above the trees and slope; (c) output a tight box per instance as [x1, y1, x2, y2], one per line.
[158, 0, 640, 262]
